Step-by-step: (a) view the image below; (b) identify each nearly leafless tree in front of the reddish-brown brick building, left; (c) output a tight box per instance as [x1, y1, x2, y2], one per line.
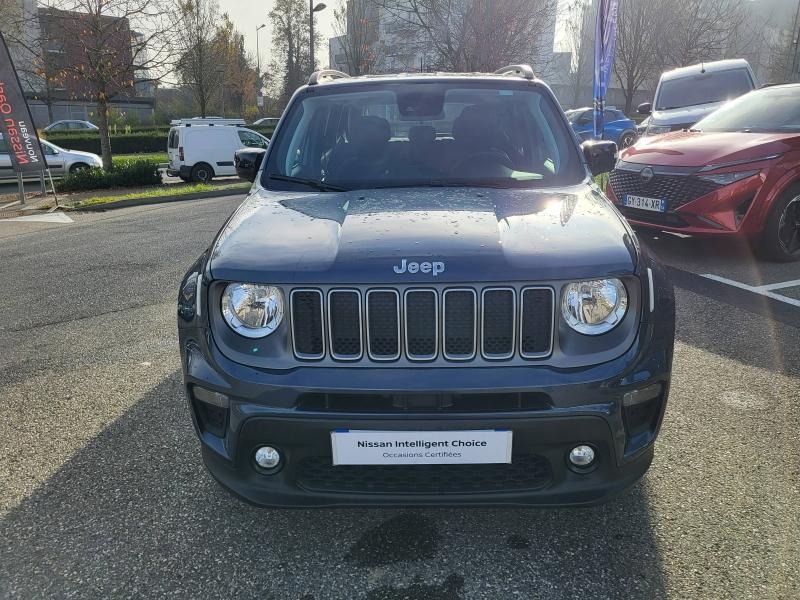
[32, 0, 173, 170]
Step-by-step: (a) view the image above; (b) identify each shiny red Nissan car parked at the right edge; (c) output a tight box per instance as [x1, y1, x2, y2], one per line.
[607, 84, 800, 262]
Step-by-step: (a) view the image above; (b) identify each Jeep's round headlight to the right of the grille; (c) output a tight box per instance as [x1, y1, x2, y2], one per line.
[561, 279, 628, 335]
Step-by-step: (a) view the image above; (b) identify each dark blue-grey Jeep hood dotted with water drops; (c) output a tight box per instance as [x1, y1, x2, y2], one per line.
[210, 185, 636, 285]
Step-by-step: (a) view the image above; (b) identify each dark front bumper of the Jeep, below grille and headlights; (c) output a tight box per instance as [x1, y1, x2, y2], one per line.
[180, 320, 674, 506]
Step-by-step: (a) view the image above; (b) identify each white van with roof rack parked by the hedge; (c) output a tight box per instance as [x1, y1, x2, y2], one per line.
[167, 118, 269, 181]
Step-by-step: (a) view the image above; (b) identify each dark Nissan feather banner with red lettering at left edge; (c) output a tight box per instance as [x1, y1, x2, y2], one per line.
[0, 33, 47, 173]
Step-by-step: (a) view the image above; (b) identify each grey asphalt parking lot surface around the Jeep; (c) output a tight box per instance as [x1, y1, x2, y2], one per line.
[0, 197, 800, 600]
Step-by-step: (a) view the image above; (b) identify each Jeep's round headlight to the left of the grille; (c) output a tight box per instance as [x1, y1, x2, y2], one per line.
[222, 283, 283, 338]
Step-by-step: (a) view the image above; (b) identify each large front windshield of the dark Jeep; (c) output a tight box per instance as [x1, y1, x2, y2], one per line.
[262, 81, 585, 190]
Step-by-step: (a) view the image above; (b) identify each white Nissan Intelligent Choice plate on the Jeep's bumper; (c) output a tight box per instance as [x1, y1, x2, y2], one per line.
[331, 429, 512, 465]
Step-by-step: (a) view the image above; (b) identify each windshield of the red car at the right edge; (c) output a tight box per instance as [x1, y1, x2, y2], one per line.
[694, 86, 800, 133]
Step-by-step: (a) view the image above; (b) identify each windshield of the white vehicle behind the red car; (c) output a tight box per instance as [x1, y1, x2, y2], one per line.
[656, 69, 753, 110]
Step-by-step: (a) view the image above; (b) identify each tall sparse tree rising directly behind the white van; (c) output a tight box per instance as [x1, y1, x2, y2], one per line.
[176, 0, 223, 117]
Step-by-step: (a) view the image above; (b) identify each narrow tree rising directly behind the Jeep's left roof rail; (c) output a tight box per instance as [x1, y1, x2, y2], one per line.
[333, 0, 382, 76]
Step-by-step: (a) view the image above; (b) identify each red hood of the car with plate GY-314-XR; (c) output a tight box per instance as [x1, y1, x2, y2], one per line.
[620, 131, 798, 167]
